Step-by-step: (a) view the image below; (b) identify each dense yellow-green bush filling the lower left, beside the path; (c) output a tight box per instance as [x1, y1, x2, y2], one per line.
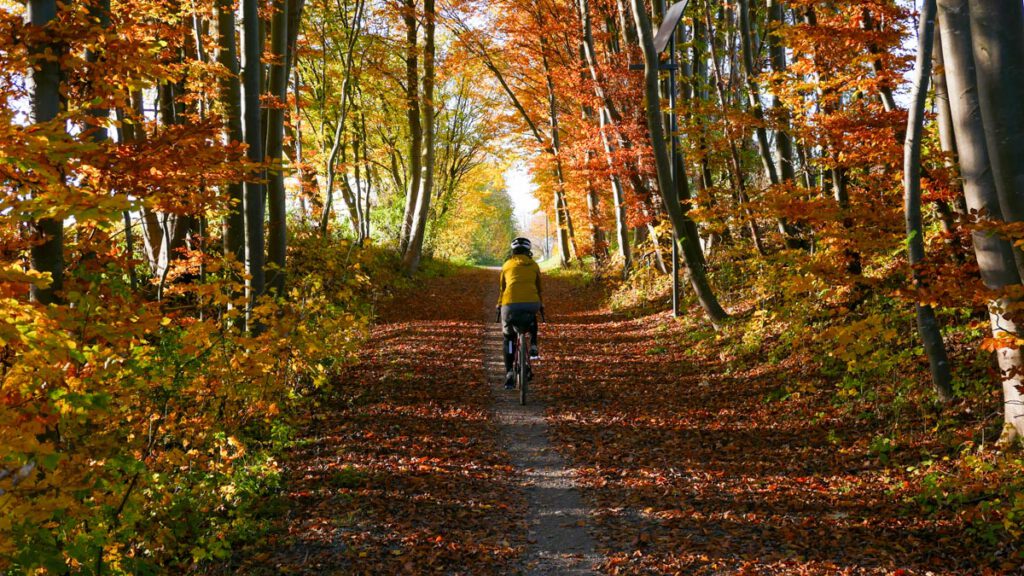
[0, 223, 385, 574]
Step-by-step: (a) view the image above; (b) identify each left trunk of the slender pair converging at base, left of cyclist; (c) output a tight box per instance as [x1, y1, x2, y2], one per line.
[398, 0, 423, 256]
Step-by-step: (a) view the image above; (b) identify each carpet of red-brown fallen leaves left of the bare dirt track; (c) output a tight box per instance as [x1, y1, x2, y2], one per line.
[238, 271, 524, 575]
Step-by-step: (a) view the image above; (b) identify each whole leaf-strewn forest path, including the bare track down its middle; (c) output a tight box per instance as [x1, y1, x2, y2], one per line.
[234, 270, 1009, 575]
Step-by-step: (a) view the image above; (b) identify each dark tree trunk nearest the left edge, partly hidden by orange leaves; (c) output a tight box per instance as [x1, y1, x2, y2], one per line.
[25, 0, 63, 304]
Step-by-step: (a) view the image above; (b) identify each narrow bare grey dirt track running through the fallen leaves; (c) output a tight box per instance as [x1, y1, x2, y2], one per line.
[483, 274, 599, 576]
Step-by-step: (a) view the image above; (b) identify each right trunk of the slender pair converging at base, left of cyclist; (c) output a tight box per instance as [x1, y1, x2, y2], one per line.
[402, 0, 436, 276]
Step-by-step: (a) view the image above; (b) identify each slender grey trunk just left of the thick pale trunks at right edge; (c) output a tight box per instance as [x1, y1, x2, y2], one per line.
[903, 0, 953, 403]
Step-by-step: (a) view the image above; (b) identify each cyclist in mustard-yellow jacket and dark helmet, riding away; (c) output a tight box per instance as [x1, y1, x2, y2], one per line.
[498, 238, 544, 388]
